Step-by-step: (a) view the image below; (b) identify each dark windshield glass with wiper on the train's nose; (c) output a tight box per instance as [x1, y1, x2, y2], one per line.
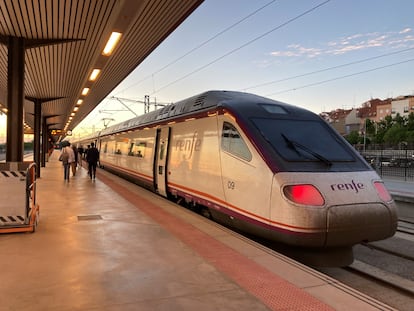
[252, 118, 355, 165]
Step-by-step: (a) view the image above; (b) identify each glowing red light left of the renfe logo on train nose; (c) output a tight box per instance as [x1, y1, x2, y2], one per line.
[283, 185, 325, 206]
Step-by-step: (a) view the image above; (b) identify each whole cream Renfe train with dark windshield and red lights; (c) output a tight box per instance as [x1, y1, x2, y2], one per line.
[79, 91, 397, 265]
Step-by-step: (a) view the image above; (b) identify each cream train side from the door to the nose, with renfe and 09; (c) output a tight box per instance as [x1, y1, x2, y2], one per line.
[168, 115, 273, 234]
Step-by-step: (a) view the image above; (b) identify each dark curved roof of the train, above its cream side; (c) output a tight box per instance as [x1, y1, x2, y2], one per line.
[100, 91, 313, 136]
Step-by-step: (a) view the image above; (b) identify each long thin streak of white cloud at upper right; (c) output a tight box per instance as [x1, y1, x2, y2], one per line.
[270, 28, 414, 58]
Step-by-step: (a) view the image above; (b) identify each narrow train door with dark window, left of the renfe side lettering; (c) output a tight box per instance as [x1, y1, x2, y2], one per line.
[154, 127, 170, 197]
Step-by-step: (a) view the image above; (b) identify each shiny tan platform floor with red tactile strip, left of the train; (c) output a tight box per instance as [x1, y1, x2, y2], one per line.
[0, 152, 393, 311]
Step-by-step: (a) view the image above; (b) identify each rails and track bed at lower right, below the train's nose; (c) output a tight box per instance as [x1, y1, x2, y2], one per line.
[316, 219, 414, 311]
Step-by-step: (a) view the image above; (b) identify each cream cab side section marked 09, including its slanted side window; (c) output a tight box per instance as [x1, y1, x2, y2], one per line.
[218, 114, 273, 235]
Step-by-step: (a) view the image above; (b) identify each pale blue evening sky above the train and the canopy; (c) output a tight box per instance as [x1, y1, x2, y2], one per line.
[2, 0, 414, 140]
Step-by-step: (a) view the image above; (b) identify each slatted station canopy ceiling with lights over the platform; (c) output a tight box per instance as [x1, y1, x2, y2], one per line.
[0, 0, 203, 139]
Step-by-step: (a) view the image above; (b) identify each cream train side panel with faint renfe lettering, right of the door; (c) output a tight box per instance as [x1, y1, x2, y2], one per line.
[167, 116, 224, 207]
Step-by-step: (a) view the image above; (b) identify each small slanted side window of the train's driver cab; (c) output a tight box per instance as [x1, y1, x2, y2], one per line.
[221, 122, 252, 161]
